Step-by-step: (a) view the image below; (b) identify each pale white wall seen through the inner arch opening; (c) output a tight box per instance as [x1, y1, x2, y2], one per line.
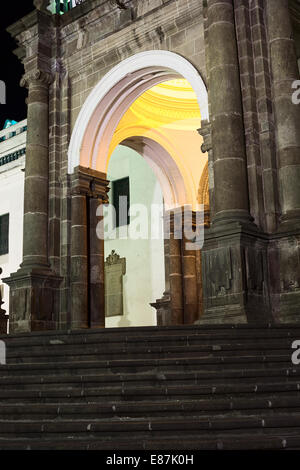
[105, 146, 165, 327]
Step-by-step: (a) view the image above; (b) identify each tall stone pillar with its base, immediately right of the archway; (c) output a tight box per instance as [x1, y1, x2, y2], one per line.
[200, 0, 271, 324]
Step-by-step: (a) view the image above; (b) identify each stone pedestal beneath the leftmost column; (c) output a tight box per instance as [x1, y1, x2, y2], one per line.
[3, 268, 62, 333]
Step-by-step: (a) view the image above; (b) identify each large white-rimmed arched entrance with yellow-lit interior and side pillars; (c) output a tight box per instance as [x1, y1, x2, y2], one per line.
[69, 51, 208, 327]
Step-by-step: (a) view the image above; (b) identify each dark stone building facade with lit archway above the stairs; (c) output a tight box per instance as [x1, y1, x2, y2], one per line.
[5, 0, 300, 332]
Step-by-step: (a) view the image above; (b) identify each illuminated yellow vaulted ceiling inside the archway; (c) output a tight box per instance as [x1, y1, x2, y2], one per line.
[109, 79, 207, 207]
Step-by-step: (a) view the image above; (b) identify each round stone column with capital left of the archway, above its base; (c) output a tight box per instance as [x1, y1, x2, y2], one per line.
[21, 71, 51, 270]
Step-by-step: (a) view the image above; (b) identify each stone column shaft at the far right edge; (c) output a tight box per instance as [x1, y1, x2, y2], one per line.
[265, 0, 300, 230]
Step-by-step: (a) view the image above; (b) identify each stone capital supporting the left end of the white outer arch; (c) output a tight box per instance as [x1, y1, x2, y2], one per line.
[71, 166, 109, 203]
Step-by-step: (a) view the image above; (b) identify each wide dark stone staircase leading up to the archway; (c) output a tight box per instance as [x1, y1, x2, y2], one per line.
[0, 325, 300, 450]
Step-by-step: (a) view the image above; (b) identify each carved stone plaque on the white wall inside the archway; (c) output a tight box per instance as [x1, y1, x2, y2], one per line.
[105, 250, 126, 317]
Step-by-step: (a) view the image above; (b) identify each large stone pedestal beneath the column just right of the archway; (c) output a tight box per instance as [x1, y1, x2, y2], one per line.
[202, 222, 272, 324]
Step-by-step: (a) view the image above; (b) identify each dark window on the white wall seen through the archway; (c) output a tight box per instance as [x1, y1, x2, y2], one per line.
[112, 177, 130, 228]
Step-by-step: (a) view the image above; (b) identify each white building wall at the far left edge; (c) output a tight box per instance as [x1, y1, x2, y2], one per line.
[0, 121, 26, 320]
